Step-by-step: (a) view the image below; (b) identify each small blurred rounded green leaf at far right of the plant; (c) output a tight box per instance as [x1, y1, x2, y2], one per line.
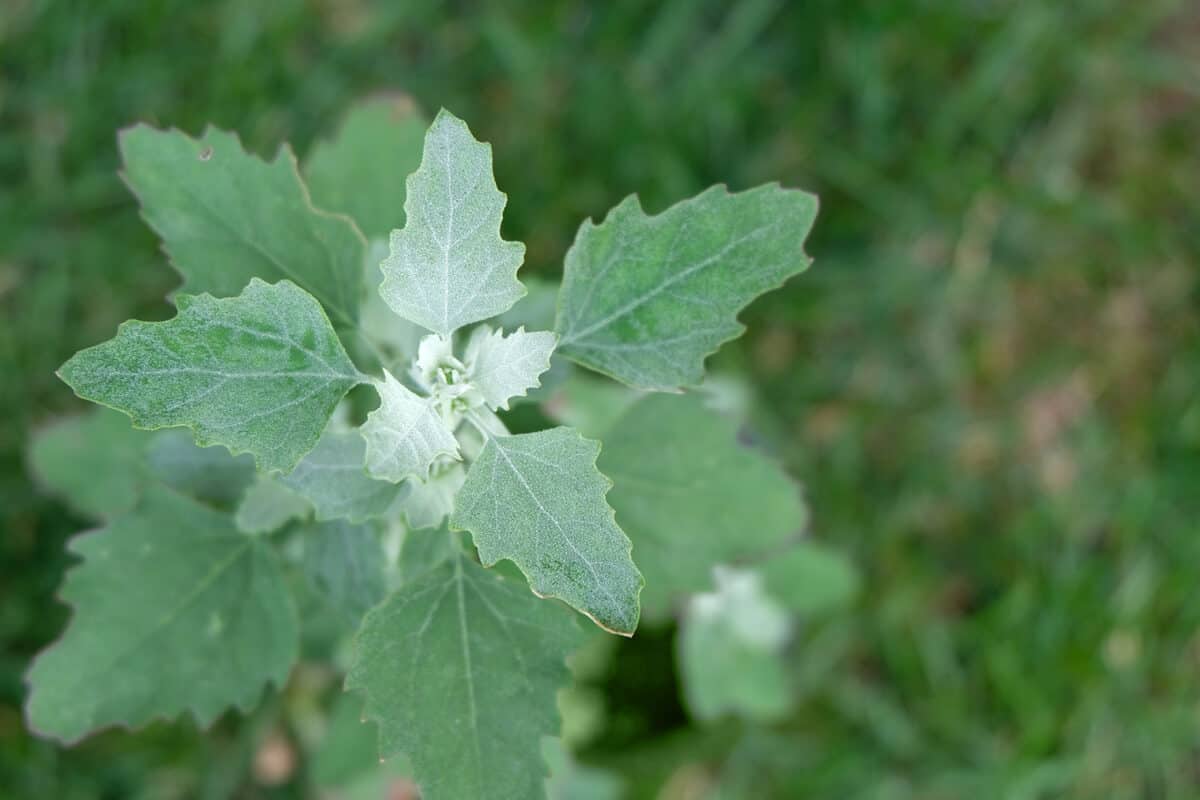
[757, 541, 859, 616]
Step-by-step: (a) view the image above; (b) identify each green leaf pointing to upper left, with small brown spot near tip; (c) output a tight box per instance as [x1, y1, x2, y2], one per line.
[120, 125, 366, 330]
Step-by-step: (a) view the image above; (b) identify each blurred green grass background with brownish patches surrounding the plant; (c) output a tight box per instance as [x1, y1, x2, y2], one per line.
[0, 0, 1200, 799]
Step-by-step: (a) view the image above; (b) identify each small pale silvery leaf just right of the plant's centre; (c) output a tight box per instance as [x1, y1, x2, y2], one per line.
[463, 325, 557, 410]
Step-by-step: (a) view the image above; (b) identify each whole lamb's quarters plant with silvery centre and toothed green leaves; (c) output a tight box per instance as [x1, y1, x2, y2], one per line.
[26, 98, 835, 800]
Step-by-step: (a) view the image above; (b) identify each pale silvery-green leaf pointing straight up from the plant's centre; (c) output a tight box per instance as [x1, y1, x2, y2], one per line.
[379, 109, 524, 336]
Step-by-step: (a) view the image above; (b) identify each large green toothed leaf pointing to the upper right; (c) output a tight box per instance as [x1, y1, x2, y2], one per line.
[554, 184, 817, 391]
